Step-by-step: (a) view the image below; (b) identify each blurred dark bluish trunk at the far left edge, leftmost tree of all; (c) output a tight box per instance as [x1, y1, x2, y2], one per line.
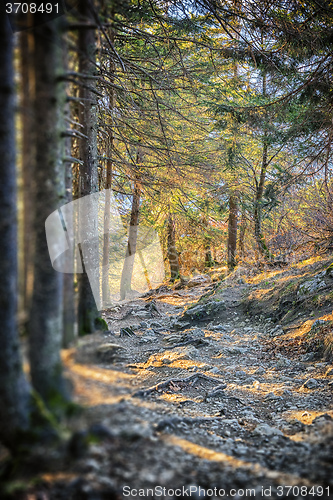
[0, 15, 30, 447]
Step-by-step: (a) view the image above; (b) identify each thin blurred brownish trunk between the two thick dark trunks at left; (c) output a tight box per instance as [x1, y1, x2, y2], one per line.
[20, 30, 34, 311]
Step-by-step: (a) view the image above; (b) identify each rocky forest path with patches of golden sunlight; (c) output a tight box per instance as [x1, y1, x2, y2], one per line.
[64, 283, 333, 498]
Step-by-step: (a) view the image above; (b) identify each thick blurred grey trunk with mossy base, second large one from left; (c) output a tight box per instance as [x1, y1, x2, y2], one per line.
[29, 14, 67, 407]
